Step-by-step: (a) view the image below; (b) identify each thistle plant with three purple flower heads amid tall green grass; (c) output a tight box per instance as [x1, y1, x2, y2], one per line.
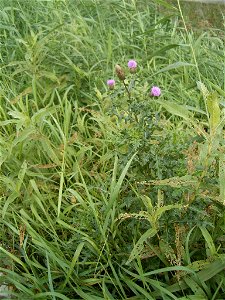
[107, 59, 168, 182]
